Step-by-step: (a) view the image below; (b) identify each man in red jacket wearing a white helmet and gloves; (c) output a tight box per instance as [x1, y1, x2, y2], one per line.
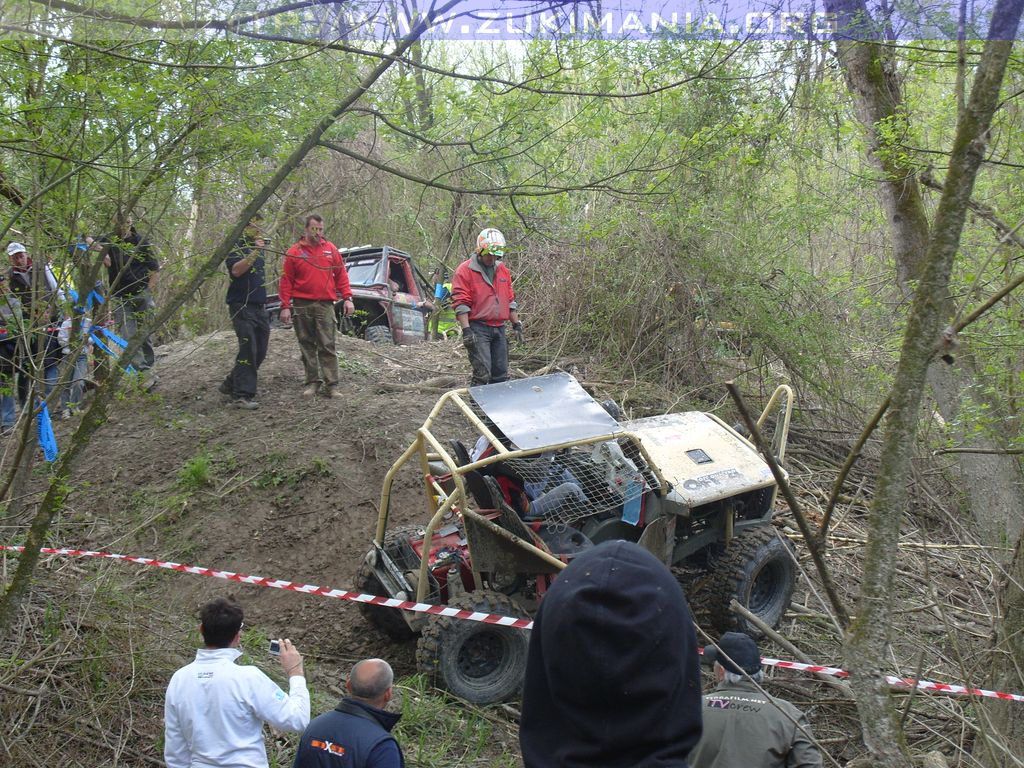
[452, 227, 522, 386]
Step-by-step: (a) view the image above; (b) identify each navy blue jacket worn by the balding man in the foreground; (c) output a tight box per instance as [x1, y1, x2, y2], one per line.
[293, 698, 406, 768]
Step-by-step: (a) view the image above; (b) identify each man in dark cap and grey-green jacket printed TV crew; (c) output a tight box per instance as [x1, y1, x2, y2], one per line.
[689, 632, 821, 768]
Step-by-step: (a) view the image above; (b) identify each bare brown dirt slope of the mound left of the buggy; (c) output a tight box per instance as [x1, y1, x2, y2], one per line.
[62, 328, 468, 675]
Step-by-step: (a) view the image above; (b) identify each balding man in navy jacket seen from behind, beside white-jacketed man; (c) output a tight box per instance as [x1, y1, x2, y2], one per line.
[293, 658, 406, 768]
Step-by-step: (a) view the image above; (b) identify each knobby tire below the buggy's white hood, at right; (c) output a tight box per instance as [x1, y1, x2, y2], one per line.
[705, 525, 797, 638]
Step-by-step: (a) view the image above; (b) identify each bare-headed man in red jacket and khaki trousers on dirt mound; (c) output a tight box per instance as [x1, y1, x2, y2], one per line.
[279, 213, 355, 397]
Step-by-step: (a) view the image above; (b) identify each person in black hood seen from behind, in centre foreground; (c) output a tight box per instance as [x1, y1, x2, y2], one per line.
[519, 542, 701, 768]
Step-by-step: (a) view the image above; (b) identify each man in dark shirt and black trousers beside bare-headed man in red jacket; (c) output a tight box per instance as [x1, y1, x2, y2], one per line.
[219, 215, 270, 411]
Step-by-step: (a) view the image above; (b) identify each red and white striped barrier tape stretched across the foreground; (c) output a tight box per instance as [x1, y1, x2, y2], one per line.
[0, 545, 1024, 703]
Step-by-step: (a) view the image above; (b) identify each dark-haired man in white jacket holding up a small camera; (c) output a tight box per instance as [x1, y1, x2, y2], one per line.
[164, 597, 309, 768]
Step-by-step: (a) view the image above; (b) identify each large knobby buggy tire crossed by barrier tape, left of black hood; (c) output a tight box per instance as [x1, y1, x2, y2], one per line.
[416, 590, 529, 705]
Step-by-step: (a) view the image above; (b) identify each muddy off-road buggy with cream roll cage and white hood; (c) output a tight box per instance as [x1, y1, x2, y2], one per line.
[355, 374, 796, 703]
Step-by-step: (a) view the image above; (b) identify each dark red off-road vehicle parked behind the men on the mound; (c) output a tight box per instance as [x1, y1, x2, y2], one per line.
[266, 246, 432, 345]
